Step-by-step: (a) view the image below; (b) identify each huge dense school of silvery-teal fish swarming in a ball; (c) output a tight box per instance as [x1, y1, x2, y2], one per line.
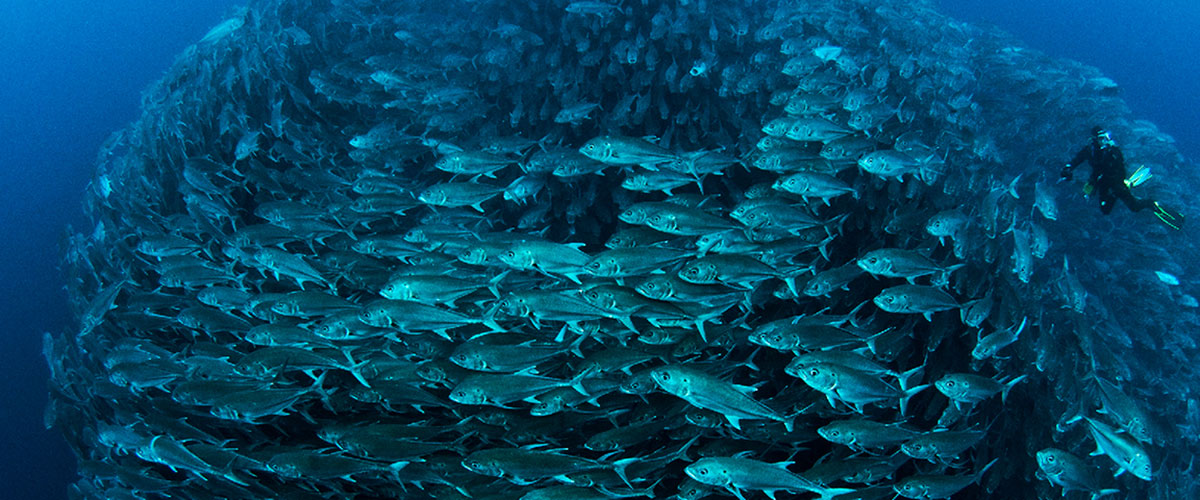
[46, 0, 1200, 500]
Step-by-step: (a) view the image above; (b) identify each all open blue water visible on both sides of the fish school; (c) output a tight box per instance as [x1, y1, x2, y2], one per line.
[0, 0, 1200, 499]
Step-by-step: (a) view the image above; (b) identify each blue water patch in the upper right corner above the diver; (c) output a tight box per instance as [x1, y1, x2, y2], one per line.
[938, 0, 1200, 161]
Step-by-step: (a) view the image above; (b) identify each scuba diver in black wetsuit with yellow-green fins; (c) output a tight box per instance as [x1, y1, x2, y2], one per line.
[1060, 127, 1183, 229]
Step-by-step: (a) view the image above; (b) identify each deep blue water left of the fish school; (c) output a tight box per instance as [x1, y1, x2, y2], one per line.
[0, 0, 242, 499]
